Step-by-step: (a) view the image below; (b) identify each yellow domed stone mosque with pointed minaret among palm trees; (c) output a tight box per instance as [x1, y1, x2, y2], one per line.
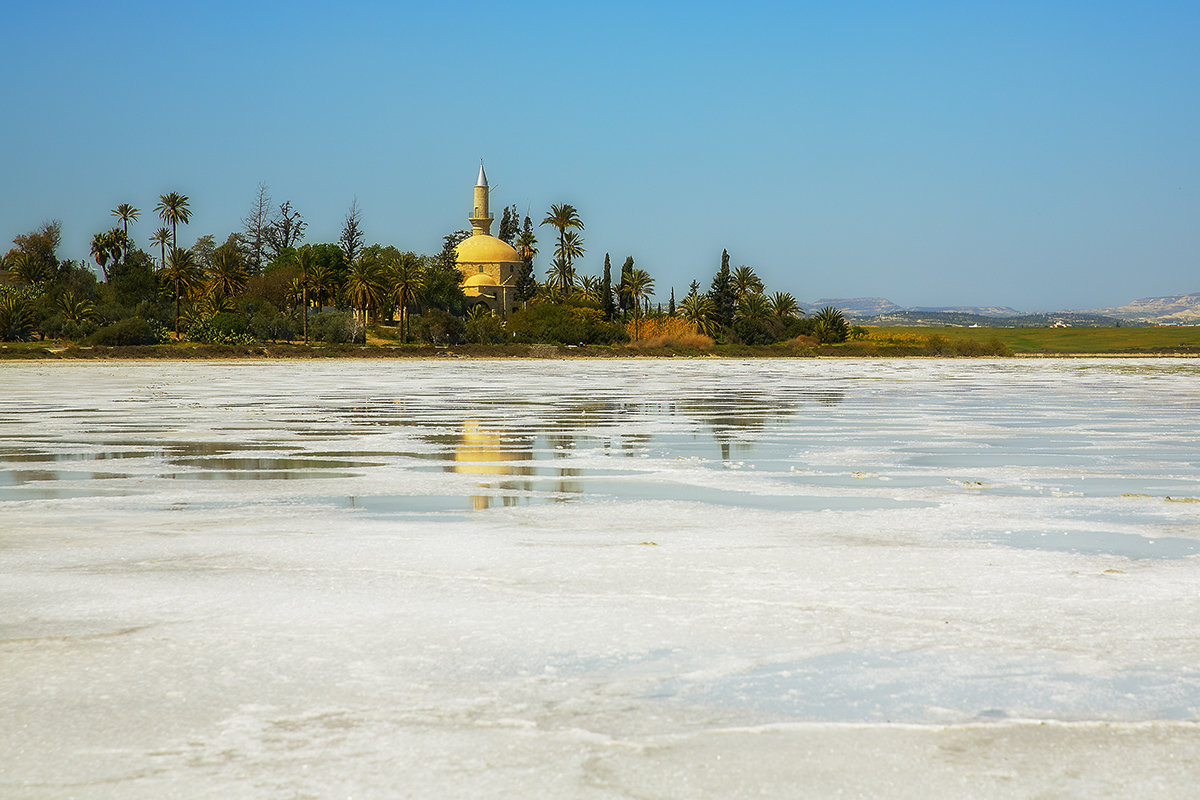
[456, 162, 521, 317]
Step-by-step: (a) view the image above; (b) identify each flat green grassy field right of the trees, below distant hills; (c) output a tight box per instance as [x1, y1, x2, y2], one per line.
[870, 326, 1200, 355]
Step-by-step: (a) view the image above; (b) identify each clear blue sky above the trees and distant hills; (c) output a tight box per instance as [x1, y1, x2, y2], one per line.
[0, 0, 1200, 309]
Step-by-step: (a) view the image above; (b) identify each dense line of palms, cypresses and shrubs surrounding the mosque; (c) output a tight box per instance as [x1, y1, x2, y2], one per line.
[0, 190, 850, 344]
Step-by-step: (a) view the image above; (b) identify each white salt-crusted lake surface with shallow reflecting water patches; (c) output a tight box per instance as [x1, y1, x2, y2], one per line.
[0, 360, 1200, 798]
